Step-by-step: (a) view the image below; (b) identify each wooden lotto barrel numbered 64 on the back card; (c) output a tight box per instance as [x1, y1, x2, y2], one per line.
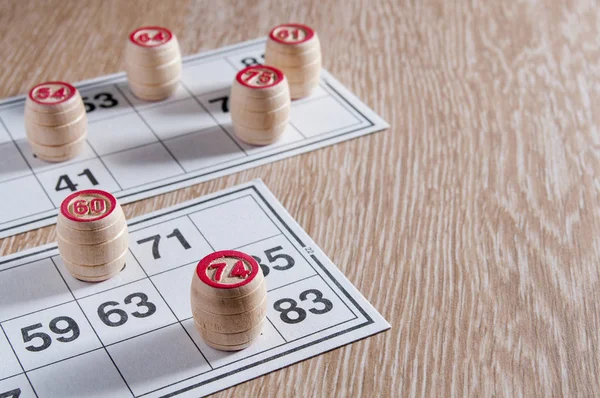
[125, 26, 181, 101]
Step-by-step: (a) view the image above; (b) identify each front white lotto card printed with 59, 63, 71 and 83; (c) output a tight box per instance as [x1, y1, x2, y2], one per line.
[0, 180, 390, 398]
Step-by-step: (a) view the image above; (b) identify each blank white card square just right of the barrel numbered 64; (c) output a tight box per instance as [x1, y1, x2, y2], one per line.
[181, 59, 237, 95]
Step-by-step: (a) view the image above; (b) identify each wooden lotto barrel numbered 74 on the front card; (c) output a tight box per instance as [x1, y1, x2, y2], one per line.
[190, 250, 267, 351]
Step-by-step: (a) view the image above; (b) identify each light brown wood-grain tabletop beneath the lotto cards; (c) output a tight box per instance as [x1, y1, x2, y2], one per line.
[0, 0, 600, 397]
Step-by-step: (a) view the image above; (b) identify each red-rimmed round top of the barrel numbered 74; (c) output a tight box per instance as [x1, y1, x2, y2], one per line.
[196, 250, 260, 289]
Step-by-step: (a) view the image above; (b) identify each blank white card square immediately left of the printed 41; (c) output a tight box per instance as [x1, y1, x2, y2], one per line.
[0, 175, 54, 235]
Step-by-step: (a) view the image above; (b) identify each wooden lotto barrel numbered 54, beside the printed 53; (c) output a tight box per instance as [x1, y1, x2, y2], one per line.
[25, 82, 87, 162]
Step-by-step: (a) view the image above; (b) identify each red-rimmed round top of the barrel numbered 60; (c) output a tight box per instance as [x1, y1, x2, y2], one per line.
[60, 189, 117, 222]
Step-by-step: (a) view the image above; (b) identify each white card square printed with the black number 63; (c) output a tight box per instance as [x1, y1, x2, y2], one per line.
[79, 279, 177, 345]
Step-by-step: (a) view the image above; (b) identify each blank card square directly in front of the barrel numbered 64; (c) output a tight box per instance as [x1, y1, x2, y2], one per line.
[140, 98, 217, 140]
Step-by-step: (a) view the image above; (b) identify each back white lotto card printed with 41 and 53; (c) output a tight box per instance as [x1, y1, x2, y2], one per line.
[0, 39, 388, 238]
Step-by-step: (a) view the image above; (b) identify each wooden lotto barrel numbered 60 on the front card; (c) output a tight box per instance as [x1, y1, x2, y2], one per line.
[56, 189, 129, 282]
